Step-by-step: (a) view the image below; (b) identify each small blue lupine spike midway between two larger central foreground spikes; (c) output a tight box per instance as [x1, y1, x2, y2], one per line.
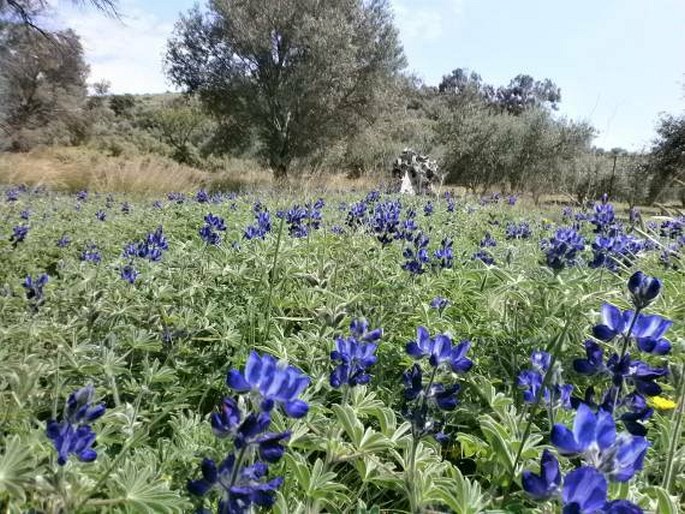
[330, 326, 382, 389]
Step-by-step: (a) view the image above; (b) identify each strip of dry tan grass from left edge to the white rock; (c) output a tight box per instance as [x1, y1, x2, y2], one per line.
[0, 147, 382, 196]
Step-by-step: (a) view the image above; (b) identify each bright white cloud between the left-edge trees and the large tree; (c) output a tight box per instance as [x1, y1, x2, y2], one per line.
[52, 0, 178, 93]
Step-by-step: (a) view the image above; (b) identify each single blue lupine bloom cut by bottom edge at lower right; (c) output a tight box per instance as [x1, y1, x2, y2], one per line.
[561, 466, 608, 514]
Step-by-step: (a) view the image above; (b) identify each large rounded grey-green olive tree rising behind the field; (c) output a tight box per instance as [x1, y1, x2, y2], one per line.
[166, 0, 405, 178]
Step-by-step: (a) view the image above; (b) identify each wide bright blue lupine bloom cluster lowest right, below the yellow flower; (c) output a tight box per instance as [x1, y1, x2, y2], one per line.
[551, 404, 650, 482]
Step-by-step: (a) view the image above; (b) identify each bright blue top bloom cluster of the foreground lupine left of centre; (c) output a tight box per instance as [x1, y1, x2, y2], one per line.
[226, 351, 310, 418]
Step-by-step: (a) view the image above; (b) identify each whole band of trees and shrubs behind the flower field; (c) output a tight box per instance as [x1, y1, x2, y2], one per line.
[0, 0, 685, 205]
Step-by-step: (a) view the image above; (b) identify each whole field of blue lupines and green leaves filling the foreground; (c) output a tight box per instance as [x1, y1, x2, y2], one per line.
[0, 187, 685, 514]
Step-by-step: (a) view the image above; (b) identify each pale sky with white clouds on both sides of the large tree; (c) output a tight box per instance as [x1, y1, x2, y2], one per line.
[52, 0, 685, 150]
